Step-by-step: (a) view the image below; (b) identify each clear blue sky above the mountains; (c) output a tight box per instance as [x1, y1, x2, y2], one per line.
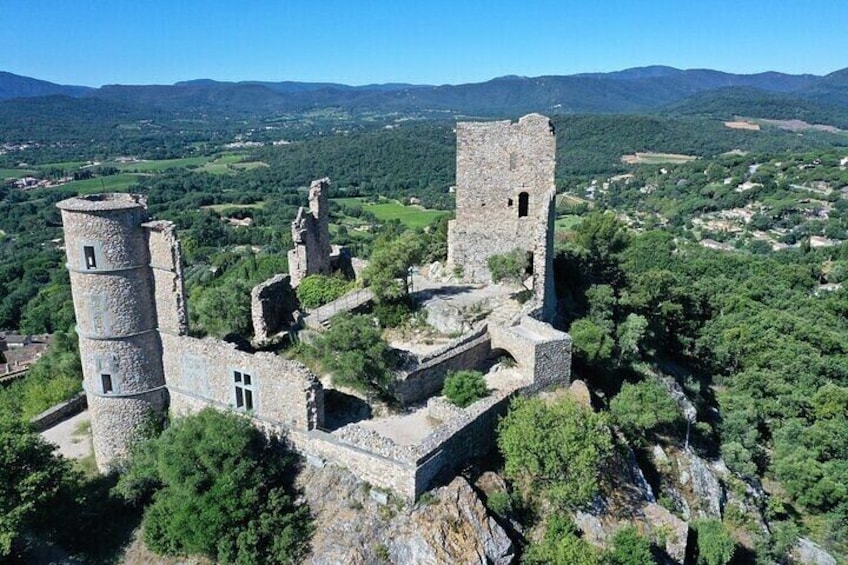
[0, 0, 848, 86]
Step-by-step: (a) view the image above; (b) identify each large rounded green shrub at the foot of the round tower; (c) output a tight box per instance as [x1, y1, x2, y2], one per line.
[116, 409, 312, 563]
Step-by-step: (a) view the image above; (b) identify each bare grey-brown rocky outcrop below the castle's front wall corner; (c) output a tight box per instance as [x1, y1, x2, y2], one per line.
[298, 466, 515, 565]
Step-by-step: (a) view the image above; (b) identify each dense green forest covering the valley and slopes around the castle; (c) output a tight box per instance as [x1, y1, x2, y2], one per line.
[0, 96, 848, 563]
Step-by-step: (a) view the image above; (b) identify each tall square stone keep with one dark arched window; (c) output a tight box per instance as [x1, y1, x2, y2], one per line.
[448, 114, 556, 319]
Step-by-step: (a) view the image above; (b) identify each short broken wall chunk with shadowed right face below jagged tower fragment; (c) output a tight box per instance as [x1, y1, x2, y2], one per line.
[250, 275, 297, 343]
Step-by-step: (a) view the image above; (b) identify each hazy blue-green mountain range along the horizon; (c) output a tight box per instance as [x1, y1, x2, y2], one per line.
[0, 66, 848, 118]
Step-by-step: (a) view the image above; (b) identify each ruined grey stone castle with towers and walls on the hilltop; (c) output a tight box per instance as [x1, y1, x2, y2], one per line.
[57, 115, 571, 499]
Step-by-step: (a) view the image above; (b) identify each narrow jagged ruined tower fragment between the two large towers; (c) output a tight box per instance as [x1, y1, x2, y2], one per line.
[288, 178, 331, 287]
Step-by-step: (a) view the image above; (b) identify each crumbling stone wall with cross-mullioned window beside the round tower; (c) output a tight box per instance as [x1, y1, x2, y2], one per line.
[162, 334, 324, 430]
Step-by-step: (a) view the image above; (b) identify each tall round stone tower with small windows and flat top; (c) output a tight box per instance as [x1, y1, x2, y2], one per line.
[57, 194, 167, 471]
